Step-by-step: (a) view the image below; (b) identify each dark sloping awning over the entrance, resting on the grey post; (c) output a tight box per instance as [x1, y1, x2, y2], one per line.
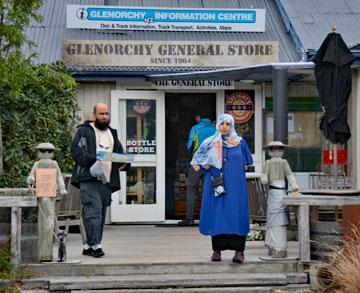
[146, 62, 315, 82]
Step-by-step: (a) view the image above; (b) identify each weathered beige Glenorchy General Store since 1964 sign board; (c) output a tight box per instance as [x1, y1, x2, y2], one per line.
[62, 40, 279, 67]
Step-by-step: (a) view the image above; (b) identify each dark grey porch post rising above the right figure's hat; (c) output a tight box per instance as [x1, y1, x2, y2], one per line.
[272, 68, 288, 144]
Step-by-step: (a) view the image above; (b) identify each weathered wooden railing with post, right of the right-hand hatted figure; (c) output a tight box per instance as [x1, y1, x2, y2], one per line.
[283, 190, 360, 263]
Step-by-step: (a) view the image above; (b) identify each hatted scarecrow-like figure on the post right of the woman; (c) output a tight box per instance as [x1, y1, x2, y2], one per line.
[261, 141, 299, 258]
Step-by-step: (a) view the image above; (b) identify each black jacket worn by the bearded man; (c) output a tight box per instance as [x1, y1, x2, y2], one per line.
[71, 122, 124, 192]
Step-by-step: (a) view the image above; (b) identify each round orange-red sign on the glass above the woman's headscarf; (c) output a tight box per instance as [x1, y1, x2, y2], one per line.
[225, 92, 255, 123]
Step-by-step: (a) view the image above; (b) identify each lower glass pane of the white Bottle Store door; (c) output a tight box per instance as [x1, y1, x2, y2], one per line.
[119, 167, 156, 204]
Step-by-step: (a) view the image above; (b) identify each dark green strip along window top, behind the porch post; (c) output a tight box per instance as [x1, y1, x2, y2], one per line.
[265, 97, 321, 111]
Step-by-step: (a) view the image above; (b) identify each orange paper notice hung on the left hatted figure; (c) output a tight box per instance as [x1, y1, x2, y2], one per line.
[35, 168, 57, 197]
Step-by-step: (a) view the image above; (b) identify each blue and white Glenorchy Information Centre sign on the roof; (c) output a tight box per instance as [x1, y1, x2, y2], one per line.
[66, 5, 265, 32]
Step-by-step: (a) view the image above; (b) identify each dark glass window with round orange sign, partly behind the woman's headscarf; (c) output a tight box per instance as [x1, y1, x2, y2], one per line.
[225, 90, 255, 154]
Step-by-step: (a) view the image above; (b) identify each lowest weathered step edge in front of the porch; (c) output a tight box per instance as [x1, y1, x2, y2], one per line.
[19, 273, 308, 291]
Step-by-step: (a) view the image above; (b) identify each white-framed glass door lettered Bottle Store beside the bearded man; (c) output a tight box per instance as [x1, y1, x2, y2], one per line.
[111, 91, 165, 222]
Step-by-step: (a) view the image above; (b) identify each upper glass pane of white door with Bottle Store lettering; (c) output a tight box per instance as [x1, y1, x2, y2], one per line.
[126, 100, 156, 155]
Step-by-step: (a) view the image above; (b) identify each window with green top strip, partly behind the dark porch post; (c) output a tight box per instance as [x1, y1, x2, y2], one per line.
[265, 97, 322, 172]
